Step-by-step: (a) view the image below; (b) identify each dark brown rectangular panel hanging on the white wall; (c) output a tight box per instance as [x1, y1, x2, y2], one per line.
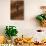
[10, 0, 24, 20]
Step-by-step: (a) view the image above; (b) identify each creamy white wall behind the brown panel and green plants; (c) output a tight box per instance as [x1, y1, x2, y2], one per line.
[0, 0, 46, 41]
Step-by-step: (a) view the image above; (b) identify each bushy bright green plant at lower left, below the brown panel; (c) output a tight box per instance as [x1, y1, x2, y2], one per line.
[5, 26, 18, 42]
